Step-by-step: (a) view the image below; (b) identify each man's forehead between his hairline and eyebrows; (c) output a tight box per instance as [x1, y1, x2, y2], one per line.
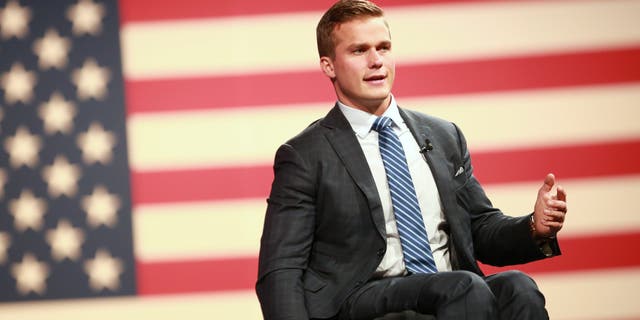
[333, 17, 391, 47]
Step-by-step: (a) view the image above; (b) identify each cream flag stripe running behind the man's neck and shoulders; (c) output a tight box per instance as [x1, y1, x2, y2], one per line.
[128, 84, 640, 170]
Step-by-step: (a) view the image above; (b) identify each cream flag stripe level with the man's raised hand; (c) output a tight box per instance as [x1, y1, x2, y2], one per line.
[133, 176, 640, 261]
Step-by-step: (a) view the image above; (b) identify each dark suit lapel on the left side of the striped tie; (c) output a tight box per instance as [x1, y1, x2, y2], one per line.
[320, 105, 386, 237]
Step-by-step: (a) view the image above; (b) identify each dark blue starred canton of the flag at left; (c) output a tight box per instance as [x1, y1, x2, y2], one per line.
[0, 1, 135, 301]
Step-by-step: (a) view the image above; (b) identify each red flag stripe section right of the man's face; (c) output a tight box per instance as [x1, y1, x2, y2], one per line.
[394, 47, 640, 97]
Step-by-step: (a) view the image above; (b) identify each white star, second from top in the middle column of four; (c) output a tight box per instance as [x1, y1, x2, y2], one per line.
[38, 92, 76, 134]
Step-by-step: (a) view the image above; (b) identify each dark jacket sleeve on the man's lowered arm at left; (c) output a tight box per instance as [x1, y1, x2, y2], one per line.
[256, 144, 315, 320]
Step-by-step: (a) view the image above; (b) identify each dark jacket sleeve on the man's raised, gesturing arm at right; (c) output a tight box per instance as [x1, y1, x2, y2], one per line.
[456, 127, 560, 266]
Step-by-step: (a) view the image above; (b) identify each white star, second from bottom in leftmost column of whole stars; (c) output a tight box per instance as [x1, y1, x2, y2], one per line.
[9, 190, 47, 231]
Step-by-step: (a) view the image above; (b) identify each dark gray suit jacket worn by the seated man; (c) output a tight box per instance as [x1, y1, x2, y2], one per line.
[256, 106, 559, 320]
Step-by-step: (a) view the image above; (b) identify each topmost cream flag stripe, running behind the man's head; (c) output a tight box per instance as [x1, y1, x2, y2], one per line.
[122, 0, 640, 79]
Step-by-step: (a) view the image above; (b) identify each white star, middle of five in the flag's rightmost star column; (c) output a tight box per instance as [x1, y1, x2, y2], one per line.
[77, 122, 116, 164]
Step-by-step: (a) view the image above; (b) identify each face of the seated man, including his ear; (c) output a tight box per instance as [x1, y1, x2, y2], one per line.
[320, 17, 395, 114]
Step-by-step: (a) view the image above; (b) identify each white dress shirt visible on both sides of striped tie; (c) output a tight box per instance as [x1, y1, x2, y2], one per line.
[338, 97, 451, 277]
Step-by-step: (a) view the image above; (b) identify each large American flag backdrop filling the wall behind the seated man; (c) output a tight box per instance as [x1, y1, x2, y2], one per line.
[0, 0, 640, 320]
